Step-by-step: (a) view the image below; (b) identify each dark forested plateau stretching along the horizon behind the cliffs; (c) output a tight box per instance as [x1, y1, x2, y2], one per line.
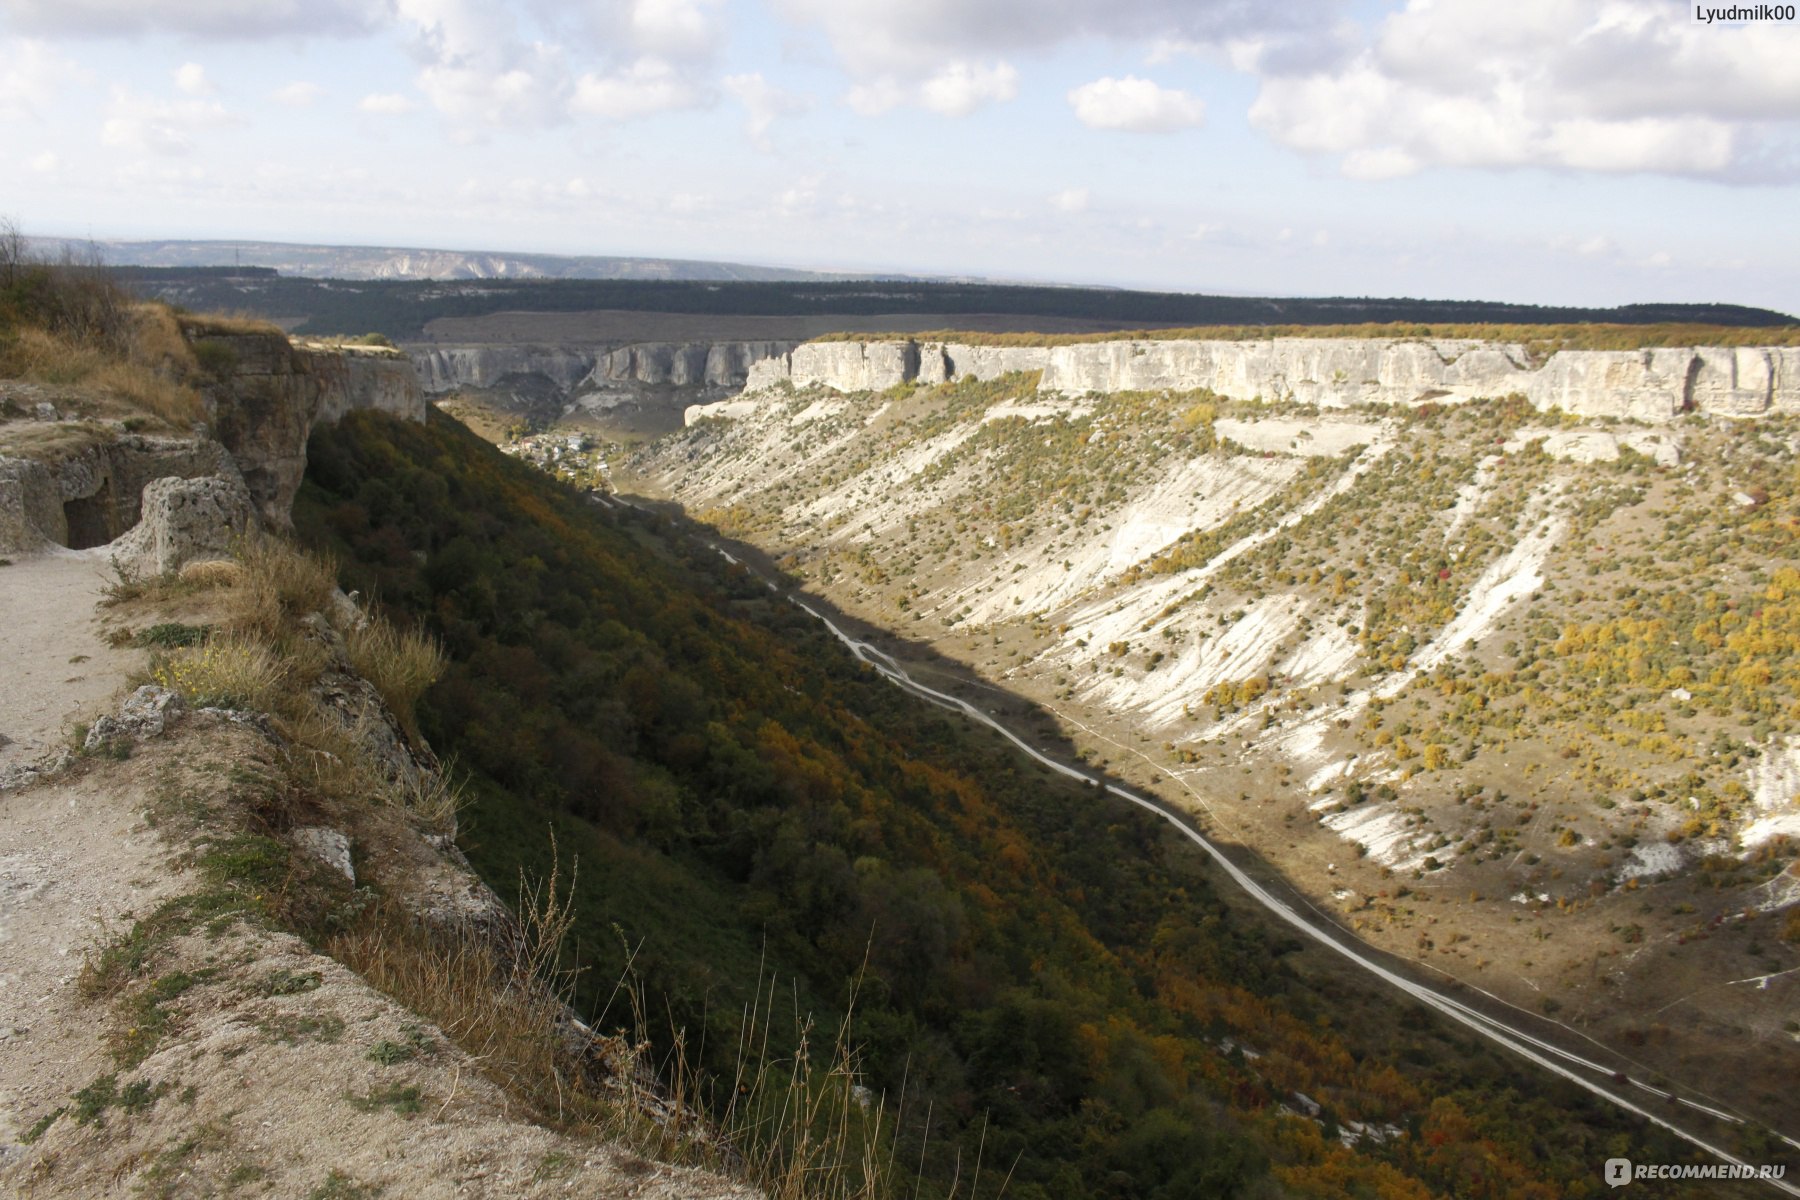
[115, 266, 1793, 340]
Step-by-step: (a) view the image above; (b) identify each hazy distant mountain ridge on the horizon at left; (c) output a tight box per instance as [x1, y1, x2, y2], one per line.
[32, 237, 868, 282]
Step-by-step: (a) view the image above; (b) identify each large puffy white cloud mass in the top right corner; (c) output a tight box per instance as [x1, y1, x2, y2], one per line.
[1244, 0, 1800, 180]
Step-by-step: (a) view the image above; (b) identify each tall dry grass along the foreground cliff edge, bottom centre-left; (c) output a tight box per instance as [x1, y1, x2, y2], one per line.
[326, 841, 895, 1200]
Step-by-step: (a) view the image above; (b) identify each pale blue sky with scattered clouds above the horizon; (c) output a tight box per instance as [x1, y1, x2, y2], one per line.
[0, 0, 1800, 313]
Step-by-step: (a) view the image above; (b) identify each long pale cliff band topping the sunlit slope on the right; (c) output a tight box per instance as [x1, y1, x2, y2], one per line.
[745, 338, 1800, 421]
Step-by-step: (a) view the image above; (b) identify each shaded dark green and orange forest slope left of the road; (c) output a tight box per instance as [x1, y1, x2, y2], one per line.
[295, 412, 1728, 1200]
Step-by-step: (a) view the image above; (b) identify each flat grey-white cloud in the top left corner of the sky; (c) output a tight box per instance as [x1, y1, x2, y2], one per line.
[0, 0, 391, 38]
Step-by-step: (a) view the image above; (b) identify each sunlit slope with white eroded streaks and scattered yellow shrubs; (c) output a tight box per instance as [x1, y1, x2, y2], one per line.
[625, 376, 1800, 1133]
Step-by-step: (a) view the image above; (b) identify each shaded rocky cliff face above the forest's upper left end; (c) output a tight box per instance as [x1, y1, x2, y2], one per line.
[193, 333, 425, 529]
